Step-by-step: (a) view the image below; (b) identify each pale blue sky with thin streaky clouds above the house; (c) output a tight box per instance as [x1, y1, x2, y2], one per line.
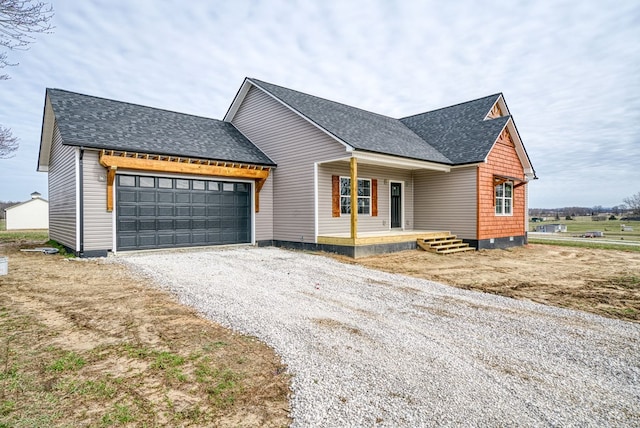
[0, 0, 640, 208]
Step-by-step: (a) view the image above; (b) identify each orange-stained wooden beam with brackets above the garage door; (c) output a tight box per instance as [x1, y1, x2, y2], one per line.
[100, 150, 271, 212]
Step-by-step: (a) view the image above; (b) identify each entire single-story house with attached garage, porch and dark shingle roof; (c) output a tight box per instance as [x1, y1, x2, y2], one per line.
[38, 78, 535, 257]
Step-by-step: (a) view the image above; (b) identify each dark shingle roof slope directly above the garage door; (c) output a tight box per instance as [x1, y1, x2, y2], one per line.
[47, 89, 275, 165]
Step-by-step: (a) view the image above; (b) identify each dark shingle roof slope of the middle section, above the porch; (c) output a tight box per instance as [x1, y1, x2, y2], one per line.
[249, 79, 451, 164]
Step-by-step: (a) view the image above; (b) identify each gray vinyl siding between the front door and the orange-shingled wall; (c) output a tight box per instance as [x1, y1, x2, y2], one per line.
[414, 166, 477, 239]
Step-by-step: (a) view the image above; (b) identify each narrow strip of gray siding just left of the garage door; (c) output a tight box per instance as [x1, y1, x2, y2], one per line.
[82, 150, 113, 251]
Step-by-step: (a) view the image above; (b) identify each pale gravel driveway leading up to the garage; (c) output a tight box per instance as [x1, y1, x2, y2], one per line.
[117, 247, 640, 427]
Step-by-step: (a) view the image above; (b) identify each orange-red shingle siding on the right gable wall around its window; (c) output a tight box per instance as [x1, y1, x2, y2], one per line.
[478, 129, 526, 239]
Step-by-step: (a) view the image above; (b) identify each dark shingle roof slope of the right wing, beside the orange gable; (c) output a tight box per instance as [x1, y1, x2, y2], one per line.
[400, 94, 510, 164]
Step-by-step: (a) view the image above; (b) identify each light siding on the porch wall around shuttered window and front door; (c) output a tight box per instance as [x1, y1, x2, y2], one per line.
[318, 162, 414, 235]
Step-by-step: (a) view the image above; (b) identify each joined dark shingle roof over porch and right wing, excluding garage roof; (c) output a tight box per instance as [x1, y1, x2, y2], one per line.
[248, 78, 510, 165]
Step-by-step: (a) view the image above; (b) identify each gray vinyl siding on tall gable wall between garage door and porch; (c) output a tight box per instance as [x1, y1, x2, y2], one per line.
[232, 87, 346, 242]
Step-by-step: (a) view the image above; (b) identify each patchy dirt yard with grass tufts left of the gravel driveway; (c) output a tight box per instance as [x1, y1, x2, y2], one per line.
[0, 239, 290, 427]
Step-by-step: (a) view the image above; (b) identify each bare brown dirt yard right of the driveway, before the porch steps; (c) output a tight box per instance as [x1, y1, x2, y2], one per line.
[341, 245, 640, 322]
